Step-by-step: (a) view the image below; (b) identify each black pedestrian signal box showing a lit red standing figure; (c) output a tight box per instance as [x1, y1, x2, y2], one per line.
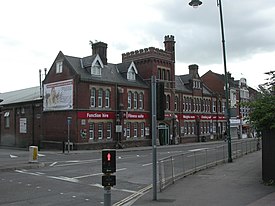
[102, 149, 116, 174]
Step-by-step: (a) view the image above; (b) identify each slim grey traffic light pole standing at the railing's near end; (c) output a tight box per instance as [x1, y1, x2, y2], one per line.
[151, 76, 157, 200]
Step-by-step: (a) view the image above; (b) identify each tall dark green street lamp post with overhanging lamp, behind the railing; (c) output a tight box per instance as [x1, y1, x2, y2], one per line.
[189, 0, 232, 162]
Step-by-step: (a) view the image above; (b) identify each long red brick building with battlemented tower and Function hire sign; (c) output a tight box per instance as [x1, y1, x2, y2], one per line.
[0, 35, 237, 149]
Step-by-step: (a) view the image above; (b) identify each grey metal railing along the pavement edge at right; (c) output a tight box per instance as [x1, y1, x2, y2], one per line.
[158, 139, 260, 191]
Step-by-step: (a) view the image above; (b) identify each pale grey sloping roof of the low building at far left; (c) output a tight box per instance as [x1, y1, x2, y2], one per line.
[0, 86, 42, 105]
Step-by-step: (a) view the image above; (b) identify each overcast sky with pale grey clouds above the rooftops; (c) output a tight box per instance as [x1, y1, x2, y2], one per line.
[0, 0, 275, 92]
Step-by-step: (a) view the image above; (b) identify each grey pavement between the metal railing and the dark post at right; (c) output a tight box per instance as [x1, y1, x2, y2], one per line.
[132, 151, 275, 206]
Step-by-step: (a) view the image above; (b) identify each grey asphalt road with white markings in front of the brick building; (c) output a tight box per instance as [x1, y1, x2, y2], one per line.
[0, 142, 246, 206]
